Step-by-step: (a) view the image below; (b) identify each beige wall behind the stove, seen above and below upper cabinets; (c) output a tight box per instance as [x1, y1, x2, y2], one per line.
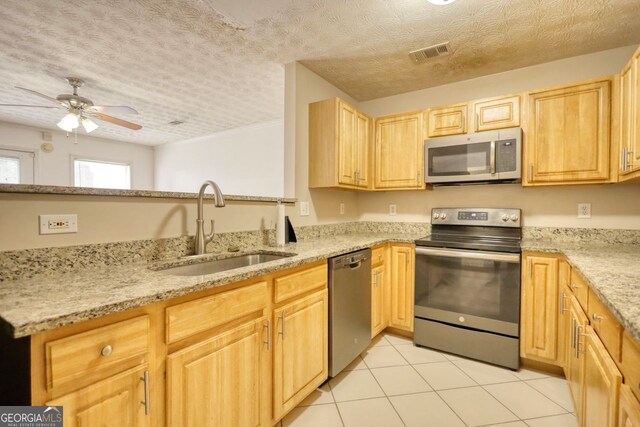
[358, 46, 640, 229]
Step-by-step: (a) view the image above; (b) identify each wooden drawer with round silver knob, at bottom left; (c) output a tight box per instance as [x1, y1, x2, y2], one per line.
[45, 316, 149, 389]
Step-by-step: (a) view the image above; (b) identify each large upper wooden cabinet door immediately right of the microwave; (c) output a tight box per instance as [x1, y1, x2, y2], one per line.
[525, 80, 611, 184]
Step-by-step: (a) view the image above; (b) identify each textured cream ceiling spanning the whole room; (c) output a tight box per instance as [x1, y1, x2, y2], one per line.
[0, 0, 640, 144]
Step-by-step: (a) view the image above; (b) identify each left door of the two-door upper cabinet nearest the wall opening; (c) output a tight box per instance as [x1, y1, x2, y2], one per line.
[338, 101, 358, 185]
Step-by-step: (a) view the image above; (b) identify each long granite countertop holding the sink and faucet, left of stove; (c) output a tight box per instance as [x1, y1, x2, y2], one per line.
[0, 233, 422, 338]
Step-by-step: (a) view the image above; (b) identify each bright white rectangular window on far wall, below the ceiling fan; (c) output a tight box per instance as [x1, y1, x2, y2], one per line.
[73, 159, 131, 190]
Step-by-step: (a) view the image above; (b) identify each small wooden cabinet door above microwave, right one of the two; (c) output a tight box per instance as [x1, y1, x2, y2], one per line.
[473, 95, 520, 132]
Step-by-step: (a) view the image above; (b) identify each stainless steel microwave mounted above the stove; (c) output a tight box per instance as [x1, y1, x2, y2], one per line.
[424, 128, 522, 185]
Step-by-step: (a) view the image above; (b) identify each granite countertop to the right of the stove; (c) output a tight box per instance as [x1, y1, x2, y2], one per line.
[522, 240, 640, 342]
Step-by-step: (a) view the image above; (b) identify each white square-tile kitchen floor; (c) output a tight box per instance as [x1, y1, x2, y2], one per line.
[281, 334, 577, 427]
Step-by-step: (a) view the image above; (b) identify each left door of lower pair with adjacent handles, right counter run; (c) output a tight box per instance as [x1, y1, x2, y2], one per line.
[565, 295, 589, 419]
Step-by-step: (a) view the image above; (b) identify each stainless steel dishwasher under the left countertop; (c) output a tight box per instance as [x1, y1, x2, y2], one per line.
[329, 249, 371, 377]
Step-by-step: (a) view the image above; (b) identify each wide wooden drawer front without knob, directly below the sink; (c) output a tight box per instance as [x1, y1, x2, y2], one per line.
[166, 282, 267, 344]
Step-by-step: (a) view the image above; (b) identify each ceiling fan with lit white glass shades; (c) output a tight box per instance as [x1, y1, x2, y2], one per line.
[0, 77, 142, 133]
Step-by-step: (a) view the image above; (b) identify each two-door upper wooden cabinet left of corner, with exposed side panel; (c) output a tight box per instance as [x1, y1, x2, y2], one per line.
[309, 98, 371, 189]
